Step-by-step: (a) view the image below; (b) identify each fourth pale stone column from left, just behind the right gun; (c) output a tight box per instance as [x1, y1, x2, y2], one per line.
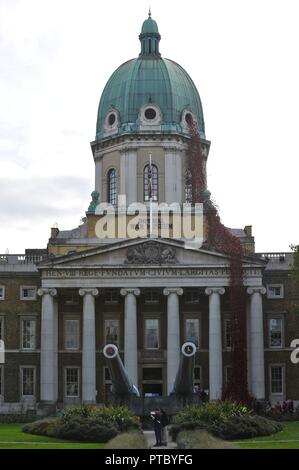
[163, 287, 183, 394]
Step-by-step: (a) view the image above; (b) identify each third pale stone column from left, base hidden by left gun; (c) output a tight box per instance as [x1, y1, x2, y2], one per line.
[120, 289, 140, 387]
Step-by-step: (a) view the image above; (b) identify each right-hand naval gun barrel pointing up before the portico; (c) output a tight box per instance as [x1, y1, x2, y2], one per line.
[171, 341, 196, 397]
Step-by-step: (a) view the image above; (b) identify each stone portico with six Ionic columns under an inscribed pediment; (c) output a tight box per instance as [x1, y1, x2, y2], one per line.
[39, 239, 264, 403]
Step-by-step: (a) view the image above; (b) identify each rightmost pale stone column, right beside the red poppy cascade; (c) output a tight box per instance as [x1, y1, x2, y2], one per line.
[247, 287, 266, 400]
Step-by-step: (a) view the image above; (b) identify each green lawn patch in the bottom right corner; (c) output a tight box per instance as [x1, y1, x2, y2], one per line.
[238, 421, 299, 449]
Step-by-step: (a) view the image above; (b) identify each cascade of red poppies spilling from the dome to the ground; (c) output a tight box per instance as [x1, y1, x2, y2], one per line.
[188, 121, 252, 404]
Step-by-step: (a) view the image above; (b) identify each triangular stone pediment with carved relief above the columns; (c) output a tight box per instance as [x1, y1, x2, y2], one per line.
[38, 239, 263, 269]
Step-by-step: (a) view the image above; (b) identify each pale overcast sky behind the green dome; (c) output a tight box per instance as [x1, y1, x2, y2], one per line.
[0, 0, 299, 253]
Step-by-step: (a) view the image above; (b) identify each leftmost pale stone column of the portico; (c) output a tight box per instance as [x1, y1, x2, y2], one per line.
[37, 288, 58, 403]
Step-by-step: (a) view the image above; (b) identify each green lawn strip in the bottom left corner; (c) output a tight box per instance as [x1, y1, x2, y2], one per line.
[0, 424, 105, 449]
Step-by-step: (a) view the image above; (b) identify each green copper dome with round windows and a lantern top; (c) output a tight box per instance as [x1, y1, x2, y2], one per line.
[96, 15, 205, 140]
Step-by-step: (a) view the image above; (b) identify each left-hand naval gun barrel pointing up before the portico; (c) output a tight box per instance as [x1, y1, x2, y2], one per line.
[103, 344, 140, 397]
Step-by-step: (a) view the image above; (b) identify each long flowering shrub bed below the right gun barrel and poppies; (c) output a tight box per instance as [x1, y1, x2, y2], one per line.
[174, 401, 252, 424]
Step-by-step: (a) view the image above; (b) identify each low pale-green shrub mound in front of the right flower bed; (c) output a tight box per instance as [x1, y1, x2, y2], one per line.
[177, 430, 235, 449]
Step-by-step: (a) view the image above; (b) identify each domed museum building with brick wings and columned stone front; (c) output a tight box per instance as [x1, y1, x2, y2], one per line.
[0, 14, 299, 413]
